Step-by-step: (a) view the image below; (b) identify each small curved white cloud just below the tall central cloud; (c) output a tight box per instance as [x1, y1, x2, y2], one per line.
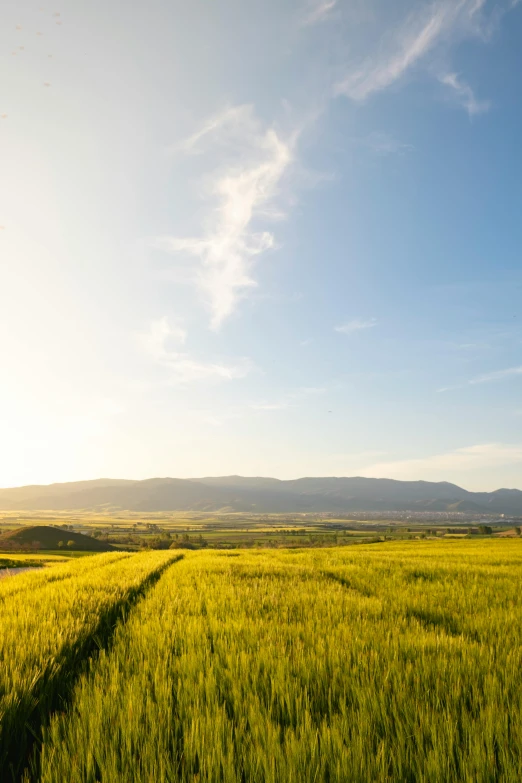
[140, 317, 253, 384]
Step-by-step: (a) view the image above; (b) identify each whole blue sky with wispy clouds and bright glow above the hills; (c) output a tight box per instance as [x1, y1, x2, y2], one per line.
[0, 0, 522, 489]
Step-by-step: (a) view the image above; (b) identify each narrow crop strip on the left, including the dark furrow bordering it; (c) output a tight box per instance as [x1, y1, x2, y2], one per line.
[0, 552, 179, 781]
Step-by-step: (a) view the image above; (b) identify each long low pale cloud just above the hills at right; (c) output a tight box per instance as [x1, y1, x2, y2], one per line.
[362, 443, 522, 479]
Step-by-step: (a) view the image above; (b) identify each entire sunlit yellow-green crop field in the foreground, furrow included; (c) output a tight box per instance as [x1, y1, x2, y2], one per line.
[0, 540, 522, 783]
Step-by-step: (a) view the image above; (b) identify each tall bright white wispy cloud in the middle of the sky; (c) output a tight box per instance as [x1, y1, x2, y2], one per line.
[155, 105, 297, 329]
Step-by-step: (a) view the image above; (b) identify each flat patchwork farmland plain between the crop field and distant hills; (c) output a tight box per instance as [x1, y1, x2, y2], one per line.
[0, 510, 522, 556]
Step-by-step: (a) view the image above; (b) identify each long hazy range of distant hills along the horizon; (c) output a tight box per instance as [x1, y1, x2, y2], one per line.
[0, 476, 522, 516]
